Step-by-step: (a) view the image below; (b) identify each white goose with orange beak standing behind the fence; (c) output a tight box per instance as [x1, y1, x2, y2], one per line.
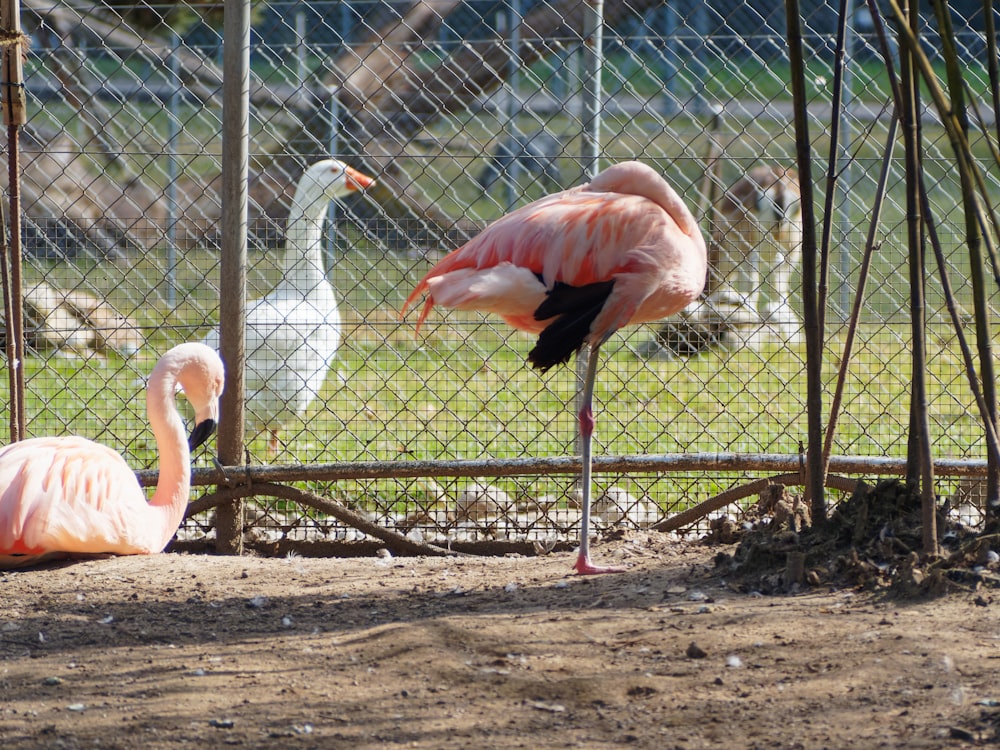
[205, 159, 374, 454]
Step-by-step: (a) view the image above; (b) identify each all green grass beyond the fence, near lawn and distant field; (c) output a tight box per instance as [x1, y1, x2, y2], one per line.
[11, 47, 1000, 524]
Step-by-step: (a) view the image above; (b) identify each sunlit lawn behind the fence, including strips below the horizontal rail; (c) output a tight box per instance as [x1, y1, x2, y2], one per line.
[0, 254, 984, 515]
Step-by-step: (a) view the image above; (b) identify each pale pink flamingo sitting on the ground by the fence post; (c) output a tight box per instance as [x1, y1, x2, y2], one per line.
[0, 343, 224, 569]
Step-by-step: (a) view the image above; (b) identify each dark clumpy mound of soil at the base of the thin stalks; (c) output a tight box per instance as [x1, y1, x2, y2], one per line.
[707, 479, 1000, 596]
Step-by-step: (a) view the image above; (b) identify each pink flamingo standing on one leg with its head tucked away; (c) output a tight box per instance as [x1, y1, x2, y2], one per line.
[403, 162, 707, 574]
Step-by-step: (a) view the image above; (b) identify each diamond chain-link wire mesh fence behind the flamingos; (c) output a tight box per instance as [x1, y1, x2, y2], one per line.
[0, 0, 998, 552]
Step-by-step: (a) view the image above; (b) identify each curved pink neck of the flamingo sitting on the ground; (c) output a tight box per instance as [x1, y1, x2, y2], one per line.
[146, 370, 191, 549]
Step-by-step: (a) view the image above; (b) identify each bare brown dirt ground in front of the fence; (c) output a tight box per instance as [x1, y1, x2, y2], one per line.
[0, 532, 1000, 750]
